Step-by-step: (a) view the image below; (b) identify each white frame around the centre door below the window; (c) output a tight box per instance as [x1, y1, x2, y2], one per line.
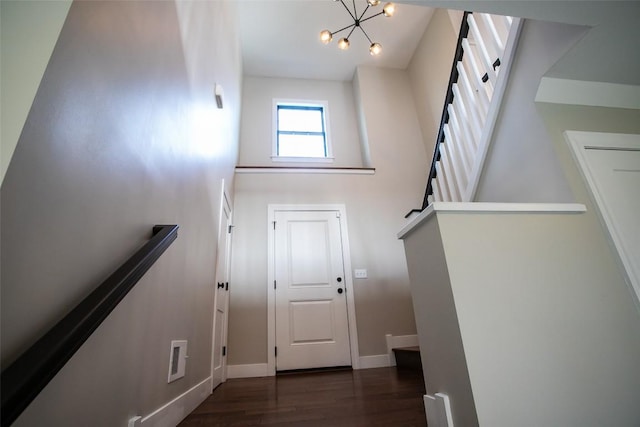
[267, 204, 360, 376]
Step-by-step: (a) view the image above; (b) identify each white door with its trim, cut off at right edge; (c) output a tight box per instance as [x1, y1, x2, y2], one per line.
[567, 132, 640, 302]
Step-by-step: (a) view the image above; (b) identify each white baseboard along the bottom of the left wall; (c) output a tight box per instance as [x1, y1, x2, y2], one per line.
[135, 377, 211, 427]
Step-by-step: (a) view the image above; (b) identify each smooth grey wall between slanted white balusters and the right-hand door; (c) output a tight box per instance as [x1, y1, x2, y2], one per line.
[475, 20, 585, 202]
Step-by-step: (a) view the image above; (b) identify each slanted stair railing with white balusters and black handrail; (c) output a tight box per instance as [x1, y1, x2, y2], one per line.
[420, 12, 521, 212]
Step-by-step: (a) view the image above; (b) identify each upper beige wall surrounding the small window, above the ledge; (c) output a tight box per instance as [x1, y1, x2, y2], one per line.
[239, 77, 363, 167]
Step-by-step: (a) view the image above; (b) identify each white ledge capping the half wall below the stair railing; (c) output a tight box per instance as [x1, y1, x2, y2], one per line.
[398, 202, 587, 239]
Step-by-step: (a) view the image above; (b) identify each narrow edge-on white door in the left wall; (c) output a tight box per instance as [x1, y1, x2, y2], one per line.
[211, 191, 231, 389]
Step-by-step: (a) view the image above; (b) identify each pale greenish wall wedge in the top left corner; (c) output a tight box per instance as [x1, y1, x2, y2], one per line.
[0, 0, 71, 183]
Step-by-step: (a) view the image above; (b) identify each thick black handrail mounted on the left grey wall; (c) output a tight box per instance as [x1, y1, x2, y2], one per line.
[0, 225, 178, 427]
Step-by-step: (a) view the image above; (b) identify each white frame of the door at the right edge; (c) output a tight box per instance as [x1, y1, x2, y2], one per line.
[564, 131, 640, 310]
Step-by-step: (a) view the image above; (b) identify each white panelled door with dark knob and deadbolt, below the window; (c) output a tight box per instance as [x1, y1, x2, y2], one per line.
[274, 211, 351, 371]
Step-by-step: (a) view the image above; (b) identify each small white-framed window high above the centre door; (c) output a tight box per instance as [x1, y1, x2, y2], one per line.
[273, 101, 332, 161]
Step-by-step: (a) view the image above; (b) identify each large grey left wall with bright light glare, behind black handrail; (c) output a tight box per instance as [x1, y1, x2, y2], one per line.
[1, 2, 241, 426]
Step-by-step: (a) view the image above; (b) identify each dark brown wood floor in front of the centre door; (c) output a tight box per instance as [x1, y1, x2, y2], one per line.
[180, 368, 426, 427]
